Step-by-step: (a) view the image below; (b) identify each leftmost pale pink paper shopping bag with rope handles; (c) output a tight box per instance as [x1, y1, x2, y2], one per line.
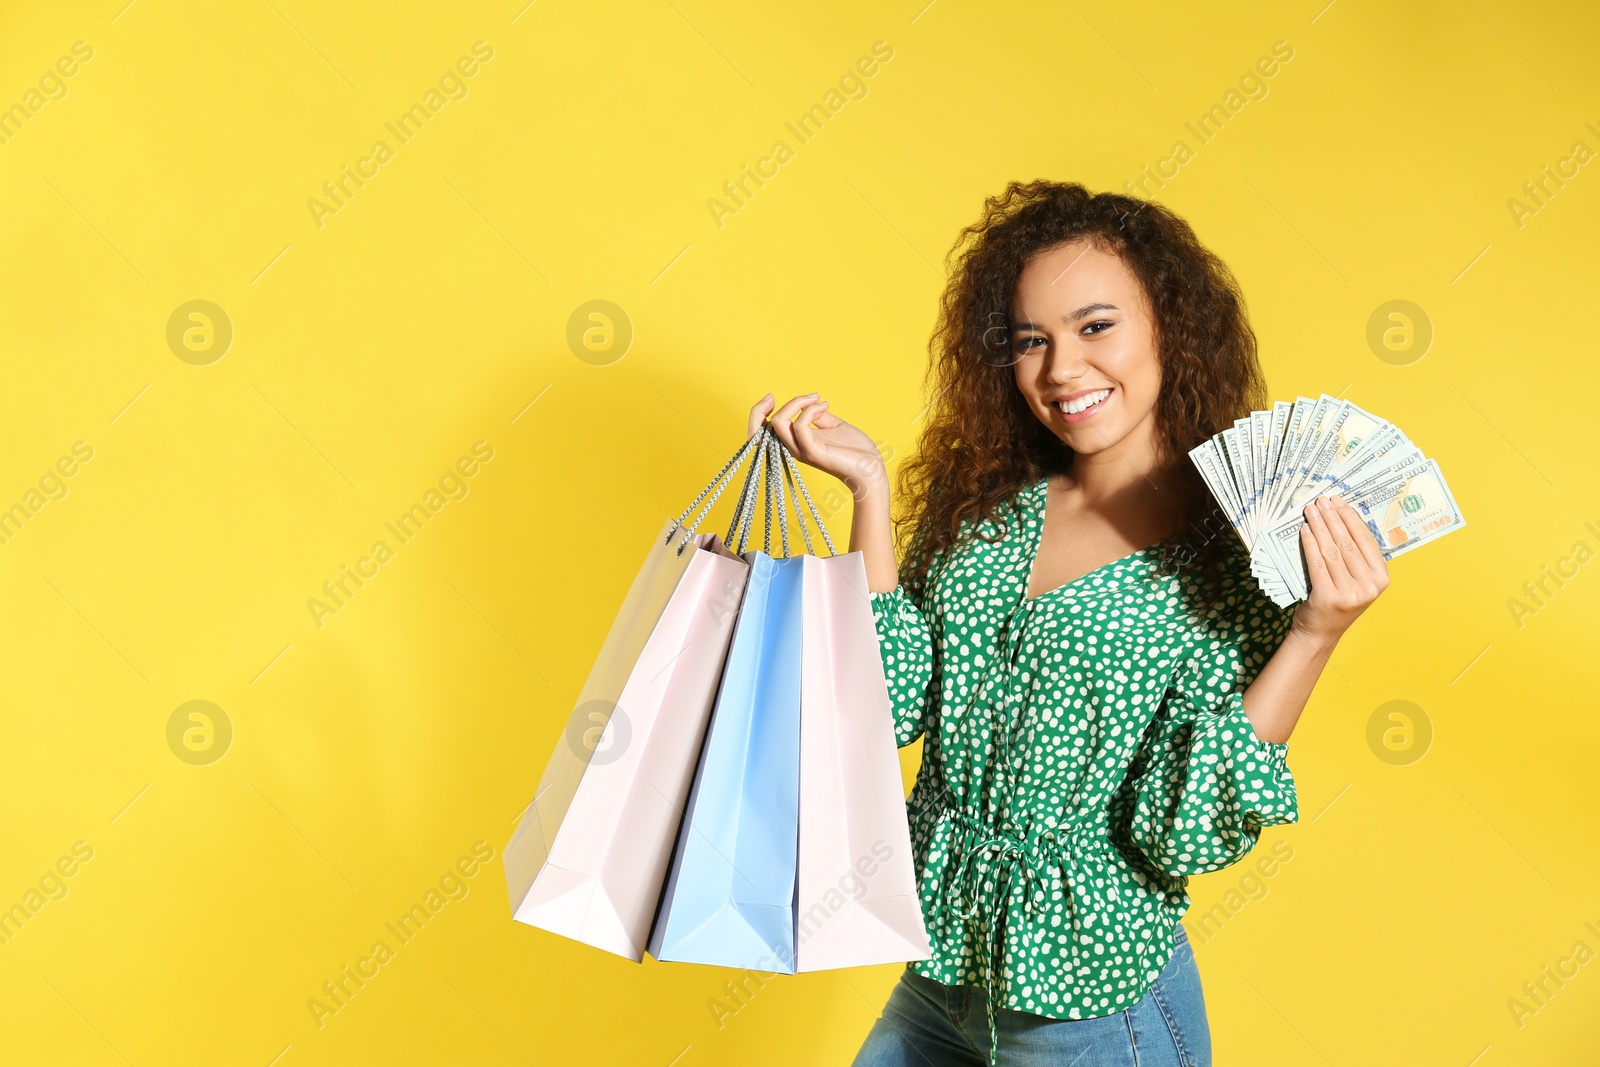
[504, 435, 762, 961]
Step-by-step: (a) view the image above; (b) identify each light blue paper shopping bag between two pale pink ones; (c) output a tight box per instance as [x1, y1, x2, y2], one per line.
[650, 531, 805, 974]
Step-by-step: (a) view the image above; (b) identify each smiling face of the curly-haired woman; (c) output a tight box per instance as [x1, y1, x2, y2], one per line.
[1011, 240, 1162, 461]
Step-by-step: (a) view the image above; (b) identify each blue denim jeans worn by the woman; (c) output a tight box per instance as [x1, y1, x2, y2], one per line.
[853, 925, 1211, 1067]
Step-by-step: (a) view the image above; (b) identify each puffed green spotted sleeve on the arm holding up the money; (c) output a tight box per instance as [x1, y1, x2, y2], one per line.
[1130, 579, 1299, 875]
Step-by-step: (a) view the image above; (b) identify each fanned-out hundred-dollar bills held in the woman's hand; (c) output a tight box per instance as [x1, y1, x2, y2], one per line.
[1189, 394, 1467, 608]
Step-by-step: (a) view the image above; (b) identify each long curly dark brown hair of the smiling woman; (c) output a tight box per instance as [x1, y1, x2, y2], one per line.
[896, 181, 1267, 611]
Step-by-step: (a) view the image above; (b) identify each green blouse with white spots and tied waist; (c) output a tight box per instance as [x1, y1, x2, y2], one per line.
[870, 478, 1298, 1049]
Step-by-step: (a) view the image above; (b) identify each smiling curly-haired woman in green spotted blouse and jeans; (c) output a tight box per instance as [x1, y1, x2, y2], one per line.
[750, 181, 1389, 1067]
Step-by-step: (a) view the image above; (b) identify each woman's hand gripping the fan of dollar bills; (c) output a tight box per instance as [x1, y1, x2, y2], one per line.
[1293, 496, 1389, 641]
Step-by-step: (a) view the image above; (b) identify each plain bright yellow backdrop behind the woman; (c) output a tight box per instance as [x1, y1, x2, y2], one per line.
[0, 0, 1600, 1067]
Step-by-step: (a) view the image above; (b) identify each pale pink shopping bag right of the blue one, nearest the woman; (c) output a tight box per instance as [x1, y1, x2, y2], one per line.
[795, 552, 931, 971]
